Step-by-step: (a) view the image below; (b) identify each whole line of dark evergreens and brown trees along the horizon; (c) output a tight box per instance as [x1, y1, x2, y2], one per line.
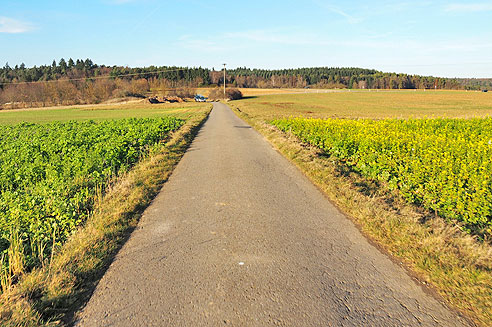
[0, 58, 492, 107]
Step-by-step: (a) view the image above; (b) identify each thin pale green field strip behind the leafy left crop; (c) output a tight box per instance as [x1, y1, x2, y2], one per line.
[0, 102, 206, 125]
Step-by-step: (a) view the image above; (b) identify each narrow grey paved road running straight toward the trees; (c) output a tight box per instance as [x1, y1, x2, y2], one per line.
[78, 103, 465, 327]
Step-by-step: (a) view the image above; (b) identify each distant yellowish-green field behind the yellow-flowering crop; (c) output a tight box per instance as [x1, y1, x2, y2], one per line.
[233, 90, 492, 120]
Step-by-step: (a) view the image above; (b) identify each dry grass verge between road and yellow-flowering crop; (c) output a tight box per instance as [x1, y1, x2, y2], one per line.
[229, 103, 492, 326]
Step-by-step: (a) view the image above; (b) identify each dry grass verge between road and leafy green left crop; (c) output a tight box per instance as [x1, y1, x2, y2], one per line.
[0, 110, 210, 326]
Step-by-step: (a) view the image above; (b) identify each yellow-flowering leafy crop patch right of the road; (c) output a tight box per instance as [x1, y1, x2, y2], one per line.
[272, 118, 492, 235]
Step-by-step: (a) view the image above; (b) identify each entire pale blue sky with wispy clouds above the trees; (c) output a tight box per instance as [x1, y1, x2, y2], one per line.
[0, 0, 492, 77]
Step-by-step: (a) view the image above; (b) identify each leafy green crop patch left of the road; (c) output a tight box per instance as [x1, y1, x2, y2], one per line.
[0, 117, 183, 274]
